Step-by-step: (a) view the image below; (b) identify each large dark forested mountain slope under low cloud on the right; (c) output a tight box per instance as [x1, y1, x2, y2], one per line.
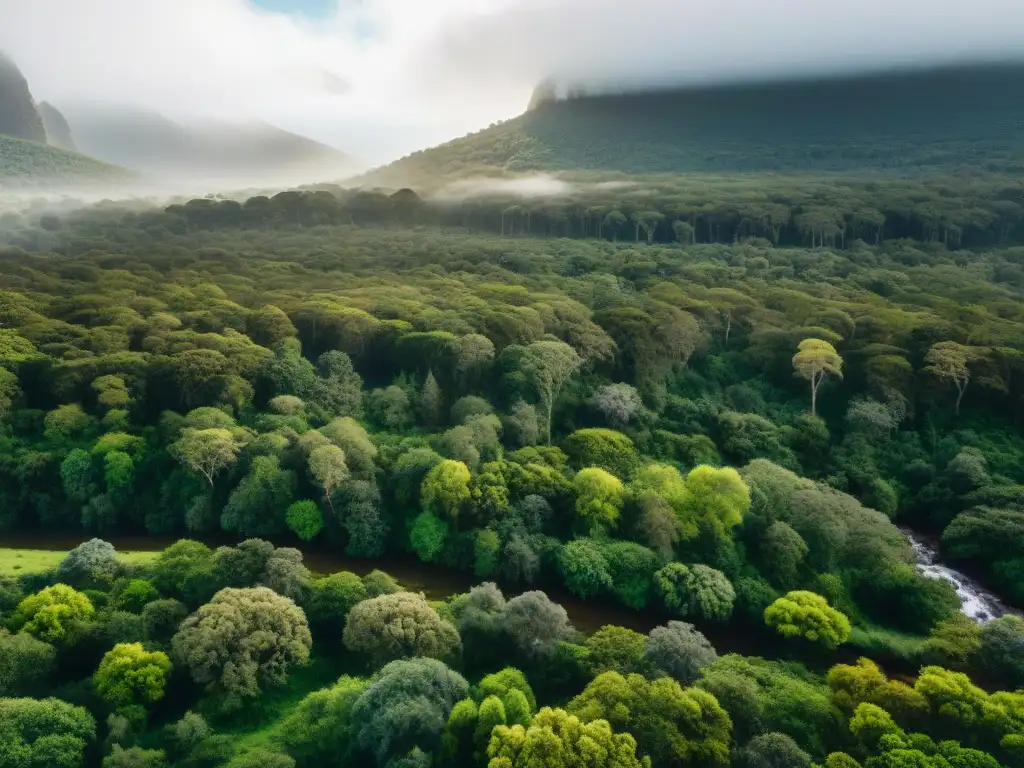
[361, 63, 1024, 187]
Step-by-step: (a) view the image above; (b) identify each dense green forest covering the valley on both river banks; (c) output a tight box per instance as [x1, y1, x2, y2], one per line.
[0, 176, 1024, 768]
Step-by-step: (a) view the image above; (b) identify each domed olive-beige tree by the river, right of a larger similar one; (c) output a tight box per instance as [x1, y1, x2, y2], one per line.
[343, 592, 462, 662]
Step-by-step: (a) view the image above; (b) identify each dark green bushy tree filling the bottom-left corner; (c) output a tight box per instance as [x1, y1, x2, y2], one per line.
[0, 698, 96, 768]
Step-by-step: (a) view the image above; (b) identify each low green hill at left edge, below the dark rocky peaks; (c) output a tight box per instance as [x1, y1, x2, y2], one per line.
[0, 136, 131, 186]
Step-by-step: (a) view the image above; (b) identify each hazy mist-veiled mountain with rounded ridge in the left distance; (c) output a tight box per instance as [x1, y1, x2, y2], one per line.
[63, 105, 352, 183]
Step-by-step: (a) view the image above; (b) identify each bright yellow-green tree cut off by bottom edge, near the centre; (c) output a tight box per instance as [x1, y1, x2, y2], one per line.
[487, 707, 642, 768]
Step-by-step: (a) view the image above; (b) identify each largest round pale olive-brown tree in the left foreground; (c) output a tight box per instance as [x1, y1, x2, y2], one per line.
[171, 587, 312, 698]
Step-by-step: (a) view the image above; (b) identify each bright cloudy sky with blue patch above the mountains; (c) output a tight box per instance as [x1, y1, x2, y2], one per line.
[0, 0, 1024, 164]
